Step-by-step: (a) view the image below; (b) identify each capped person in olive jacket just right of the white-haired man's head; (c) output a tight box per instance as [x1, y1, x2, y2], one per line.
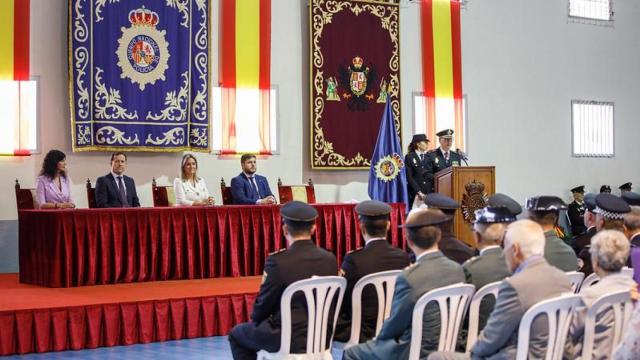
[526, 195, 578, 271]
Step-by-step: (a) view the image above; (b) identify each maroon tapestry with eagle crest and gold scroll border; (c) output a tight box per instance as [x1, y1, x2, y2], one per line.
[309, 0, 401, 170]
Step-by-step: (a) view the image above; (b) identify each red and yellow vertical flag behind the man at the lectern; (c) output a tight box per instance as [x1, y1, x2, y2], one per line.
[420, 0, 464, 148]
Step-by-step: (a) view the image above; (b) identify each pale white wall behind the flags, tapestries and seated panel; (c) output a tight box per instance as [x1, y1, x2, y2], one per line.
[0, 0, 640, 222]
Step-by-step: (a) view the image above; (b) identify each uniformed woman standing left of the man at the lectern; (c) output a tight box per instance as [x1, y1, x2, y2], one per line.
[404, 134, 433, 208]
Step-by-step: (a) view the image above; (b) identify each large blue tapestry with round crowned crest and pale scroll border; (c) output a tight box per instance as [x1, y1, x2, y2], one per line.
[69, 0, 210, 151]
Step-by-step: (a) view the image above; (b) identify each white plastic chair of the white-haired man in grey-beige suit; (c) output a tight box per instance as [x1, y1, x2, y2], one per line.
[516, 295, 584, 360]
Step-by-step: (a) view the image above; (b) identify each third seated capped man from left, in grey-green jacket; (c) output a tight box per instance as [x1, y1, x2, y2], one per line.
[343, 209, 464, 360]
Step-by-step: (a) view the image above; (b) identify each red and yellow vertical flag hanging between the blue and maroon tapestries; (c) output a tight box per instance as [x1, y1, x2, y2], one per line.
[220, 0, 271, 153]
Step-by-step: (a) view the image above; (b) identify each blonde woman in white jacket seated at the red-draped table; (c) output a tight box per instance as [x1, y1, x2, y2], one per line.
[173, 154, 215, 206]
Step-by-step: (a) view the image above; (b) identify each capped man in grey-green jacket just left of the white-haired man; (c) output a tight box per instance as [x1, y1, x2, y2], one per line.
[462, 206, 516, 330]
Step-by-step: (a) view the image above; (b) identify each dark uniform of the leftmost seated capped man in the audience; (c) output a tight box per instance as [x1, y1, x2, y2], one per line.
[246, 240, 338, 353]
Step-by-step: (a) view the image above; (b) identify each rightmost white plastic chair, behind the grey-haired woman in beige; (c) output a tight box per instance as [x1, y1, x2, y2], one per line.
[581, 290, 633, 359]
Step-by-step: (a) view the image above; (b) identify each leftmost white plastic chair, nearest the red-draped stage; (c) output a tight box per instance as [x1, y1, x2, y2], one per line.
[258, 276, 347, 360]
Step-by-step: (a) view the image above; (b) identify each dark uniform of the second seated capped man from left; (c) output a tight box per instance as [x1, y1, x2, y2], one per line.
[334, 239, 409, 342]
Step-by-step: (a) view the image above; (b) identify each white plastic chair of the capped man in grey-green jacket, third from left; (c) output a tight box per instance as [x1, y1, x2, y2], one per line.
[409, 284, 475, 360]
